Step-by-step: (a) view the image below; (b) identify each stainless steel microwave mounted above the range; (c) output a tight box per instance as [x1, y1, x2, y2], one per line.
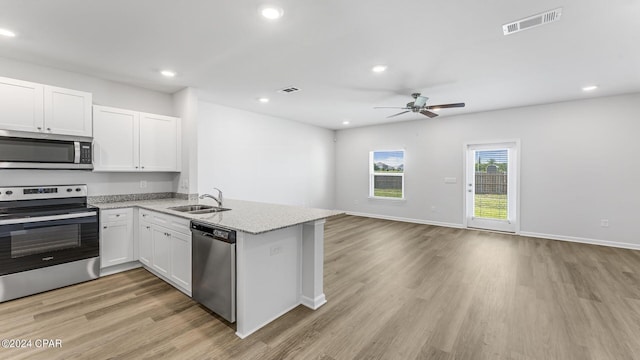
[0, 131, 93, 170]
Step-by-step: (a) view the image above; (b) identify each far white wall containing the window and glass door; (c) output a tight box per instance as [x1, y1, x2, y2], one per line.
[336, 94, 640, 248]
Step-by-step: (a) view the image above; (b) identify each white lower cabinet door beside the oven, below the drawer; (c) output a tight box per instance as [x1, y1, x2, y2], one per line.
[100, 221, 133, 268]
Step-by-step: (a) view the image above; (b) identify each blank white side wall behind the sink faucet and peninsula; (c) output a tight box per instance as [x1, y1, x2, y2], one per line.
[198, 101, 335, 208]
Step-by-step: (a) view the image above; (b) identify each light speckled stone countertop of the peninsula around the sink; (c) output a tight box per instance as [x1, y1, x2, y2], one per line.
[91, 198, 344, 234]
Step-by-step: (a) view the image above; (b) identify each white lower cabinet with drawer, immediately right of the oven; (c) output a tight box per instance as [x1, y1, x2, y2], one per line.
[100, 208, 135, 269]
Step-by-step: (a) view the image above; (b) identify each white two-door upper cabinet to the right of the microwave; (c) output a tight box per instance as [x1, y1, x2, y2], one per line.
[93, 105, 181, 172]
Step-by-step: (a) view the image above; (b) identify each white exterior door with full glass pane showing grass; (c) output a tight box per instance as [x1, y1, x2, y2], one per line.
[465, 141, 519, 232]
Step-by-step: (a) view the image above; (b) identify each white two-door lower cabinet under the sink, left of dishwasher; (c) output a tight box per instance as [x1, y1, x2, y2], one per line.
[138, 209, 191, 296]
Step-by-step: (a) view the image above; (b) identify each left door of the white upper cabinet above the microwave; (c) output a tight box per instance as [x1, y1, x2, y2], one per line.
[0, 77, 44, 132]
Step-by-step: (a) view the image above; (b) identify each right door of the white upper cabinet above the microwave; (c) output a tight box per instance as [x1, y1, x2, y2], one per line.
[44, 86, 93, 137]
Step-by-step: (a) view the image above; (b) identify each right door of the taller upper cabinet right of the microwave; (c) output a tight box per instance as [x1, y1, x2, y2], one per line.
[140, 113, 181, 171]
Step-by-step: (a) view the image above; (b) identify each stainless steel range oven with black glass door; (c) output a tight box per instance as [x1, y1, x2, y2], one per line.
[0, 185, 100, 301]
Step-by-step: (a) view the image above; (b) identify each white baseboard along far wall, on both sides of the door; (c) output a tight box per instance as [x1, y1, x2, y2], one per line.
[345, 211, 640, 250]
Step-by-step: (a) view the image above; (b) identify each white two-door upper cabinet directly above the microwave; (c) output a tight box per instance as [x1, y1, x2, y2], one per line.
[0, 78, 93, 137]
